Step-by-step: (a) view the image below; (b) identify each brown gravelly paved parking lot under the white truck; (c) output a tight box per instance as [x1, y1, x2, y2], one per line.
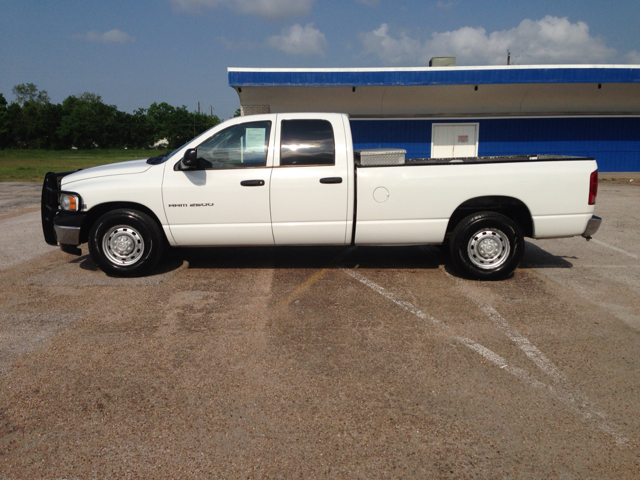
[0, 179, 640, 479]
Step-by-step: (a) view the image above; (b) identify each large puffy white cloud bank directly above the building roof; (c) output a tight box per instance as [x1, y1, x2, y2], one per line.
[360, 15, 637, 65]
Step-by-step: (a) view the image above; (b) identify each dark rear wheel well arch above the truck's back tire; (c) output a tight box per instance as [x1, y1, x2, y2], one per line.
[446, 196, 533, 237]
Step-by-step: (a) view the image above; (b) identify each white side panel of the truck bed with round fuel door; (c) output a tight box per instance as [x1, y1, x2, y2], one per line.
[355, 160, 596, 245]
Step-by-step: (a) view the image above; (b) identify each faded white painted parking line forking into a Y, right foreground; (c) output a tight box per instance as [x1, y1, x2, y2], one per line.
[338, 267, 629, 445]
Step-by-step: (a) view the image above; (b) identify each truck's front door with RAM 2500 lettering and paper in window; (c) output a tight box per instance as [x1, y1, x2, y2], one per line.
[162, 120, 274, 246]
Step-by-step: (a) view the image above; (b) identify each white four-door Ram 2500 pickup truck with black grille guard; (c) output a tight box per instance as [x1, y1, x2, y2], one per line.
[42, 113, 601, 280]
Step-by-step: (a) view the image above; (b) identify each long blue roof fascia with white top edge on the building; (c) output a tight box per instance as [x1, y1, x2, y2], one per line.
[228, 65, 640, 87]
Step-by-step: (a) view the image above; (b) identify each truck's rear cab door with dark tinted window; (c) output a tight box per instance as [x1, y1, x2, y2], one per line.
[270, 114, 350, 245]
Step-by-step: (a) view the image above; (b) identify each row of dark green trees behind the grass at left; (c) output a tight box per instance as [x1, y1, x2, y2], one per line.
[0, 83, 220, 148]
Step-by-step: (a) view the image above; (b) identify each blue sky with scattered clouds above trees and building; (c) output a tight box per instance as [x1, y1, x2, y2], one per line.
[0, 0, 640, 119]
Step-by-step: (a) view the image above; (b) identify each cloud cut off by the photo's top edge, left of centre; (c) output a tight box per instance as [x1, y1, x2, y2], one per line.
[171, 0, 315, 20]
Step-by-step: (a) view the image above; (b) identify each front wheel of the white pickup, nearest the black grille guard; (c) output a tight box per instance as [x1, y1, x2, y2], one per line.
[89, 209, 166, 277]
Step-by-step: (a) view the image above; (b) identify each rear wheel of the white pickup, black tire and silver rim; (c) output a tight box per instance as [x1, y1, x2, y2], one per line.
[450, 212, 524, 280]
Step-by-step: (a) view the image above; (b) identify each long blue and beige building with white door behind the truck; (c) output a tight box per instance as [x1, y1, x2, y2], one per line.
[228, 65, 640, 172]
